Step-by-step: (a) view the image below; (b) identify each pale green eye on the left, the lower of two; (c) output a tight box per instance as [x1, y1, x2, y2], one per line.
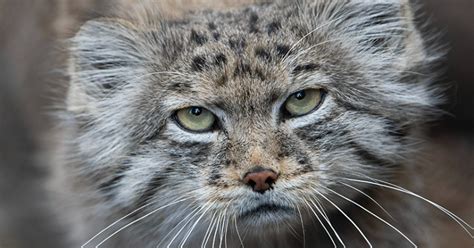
[176, 107, 216, 132]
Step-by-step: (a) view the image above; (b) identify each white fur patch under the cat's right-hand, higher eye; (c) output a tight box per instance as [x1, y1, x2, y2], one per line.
[285, 94, 335, 129]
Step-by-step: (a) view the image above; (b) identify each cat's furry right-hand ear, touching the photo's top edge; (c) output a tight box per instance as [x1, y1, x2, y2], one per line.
[311, 0, 423, 66]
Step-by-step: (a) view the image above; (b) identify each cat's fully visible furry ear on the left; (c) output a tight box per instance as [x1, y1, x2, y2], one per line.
[67, 19, 145, 112]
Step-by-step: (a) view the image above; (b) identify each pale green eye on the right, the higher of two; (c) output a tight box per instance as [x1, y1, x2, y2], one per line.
[285, 89, 323, 117]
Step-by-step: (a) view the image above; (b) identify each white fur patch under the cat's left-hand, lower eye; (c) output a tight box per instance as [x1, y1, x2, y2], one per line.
[164, 122, 218, 143]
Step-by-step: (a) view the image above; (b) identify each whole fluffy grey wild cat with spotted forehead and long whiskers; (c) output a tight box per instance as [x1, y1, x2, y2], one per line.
[51, 0, 472, 247]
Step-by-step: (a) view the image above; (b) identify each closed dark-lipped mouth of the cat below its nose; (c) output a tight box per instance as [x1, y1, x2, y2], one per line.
[239, 204, 293, 220]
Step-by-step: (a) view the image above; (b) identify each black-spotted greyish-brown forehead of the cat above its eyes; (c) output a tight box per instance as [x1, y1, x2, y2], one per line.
[153, 5, 314, 111]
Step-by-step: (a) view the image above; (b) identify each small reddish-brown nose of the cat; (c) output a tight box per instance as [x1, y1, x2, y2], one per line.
[243, 167, 278, 194]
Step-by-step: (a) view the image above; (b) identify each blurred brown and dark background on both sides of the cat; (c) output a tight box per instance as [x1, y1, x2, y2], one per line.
[0, 0, 474, 248]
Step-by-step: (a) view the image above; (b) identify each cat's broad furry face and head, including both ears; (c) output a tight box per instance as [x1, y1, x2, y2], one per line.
[68, 1, 436, 241]
